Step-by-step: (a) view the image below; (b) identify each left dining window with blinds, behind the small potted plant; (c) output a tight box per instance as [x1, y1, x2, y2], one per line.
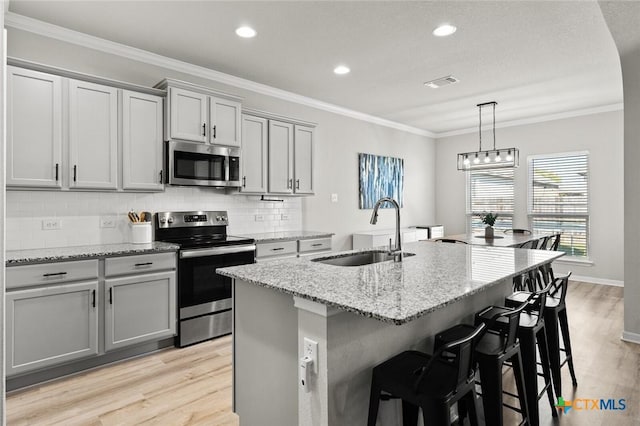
[467, 169, 513, 231]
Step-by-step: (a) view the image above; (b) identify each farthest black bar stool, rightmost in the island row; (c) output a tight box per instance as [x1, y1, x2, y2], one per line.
[505, 267, 578, 396]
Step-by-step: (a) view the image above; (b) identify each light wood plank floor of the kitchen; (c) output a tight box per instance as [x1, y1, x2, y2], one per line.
[7, 282, 640, 426]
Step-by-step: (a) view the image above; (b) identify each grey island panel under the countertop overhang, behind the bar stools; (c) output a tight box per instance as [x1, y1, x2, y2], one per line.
[324, 279, 512, 426]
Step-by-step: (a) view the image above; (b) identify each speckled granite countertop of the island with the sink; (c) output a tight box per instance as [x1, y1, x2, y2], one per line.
[217, 241, 564, 325]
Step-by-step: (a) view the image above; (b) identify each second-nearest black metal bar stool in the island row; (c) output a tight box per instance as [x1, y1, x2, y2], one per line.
[435, 299, 529, 426]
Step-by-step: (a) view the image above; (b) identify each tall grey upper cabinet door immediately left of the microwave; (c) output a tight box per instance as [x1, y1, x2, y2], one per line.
[122, 90, 164, 191]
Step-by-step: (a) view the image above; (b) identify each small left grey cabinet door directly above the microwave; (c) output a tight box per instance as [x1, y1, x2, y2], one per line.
[169, 87, 209, 142]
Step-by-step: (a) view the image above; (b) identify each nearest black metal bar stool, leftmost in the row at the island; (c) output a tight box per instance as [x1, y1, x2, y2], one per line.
[367, 324, 486, 426]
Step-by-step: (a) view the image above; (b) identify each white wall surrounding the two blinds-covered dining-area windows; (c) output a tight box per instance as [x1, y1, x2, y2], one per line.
[436, 111, 625, 282]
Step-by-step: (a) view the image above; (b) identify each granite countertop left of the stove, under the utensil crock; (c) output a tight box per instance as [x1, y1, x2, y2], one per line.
[5, 241, 180, 266]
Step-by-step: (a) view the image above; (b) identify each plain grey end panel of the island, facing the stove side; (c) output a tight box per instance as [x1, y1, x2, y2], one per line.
[233, 280, 298, 426]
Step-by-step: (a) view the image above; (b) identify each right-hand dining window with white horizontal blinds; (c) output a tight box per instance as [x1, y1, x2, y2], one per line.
[529, 152, 589, 258]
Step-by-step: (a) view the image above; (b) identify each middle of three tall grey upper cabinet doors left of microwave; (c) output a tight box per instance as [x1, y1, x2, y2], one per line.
[69, 80, 118, 189]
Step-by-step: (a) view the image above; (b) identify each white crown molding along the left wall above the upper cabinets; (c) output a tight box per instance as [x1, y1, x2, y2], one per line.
[5, 12, 435, 138]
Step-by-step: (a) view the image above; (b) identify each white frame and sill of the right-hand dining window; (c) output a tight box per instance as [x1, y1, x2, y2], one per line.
[527, 150, 591, 262]
